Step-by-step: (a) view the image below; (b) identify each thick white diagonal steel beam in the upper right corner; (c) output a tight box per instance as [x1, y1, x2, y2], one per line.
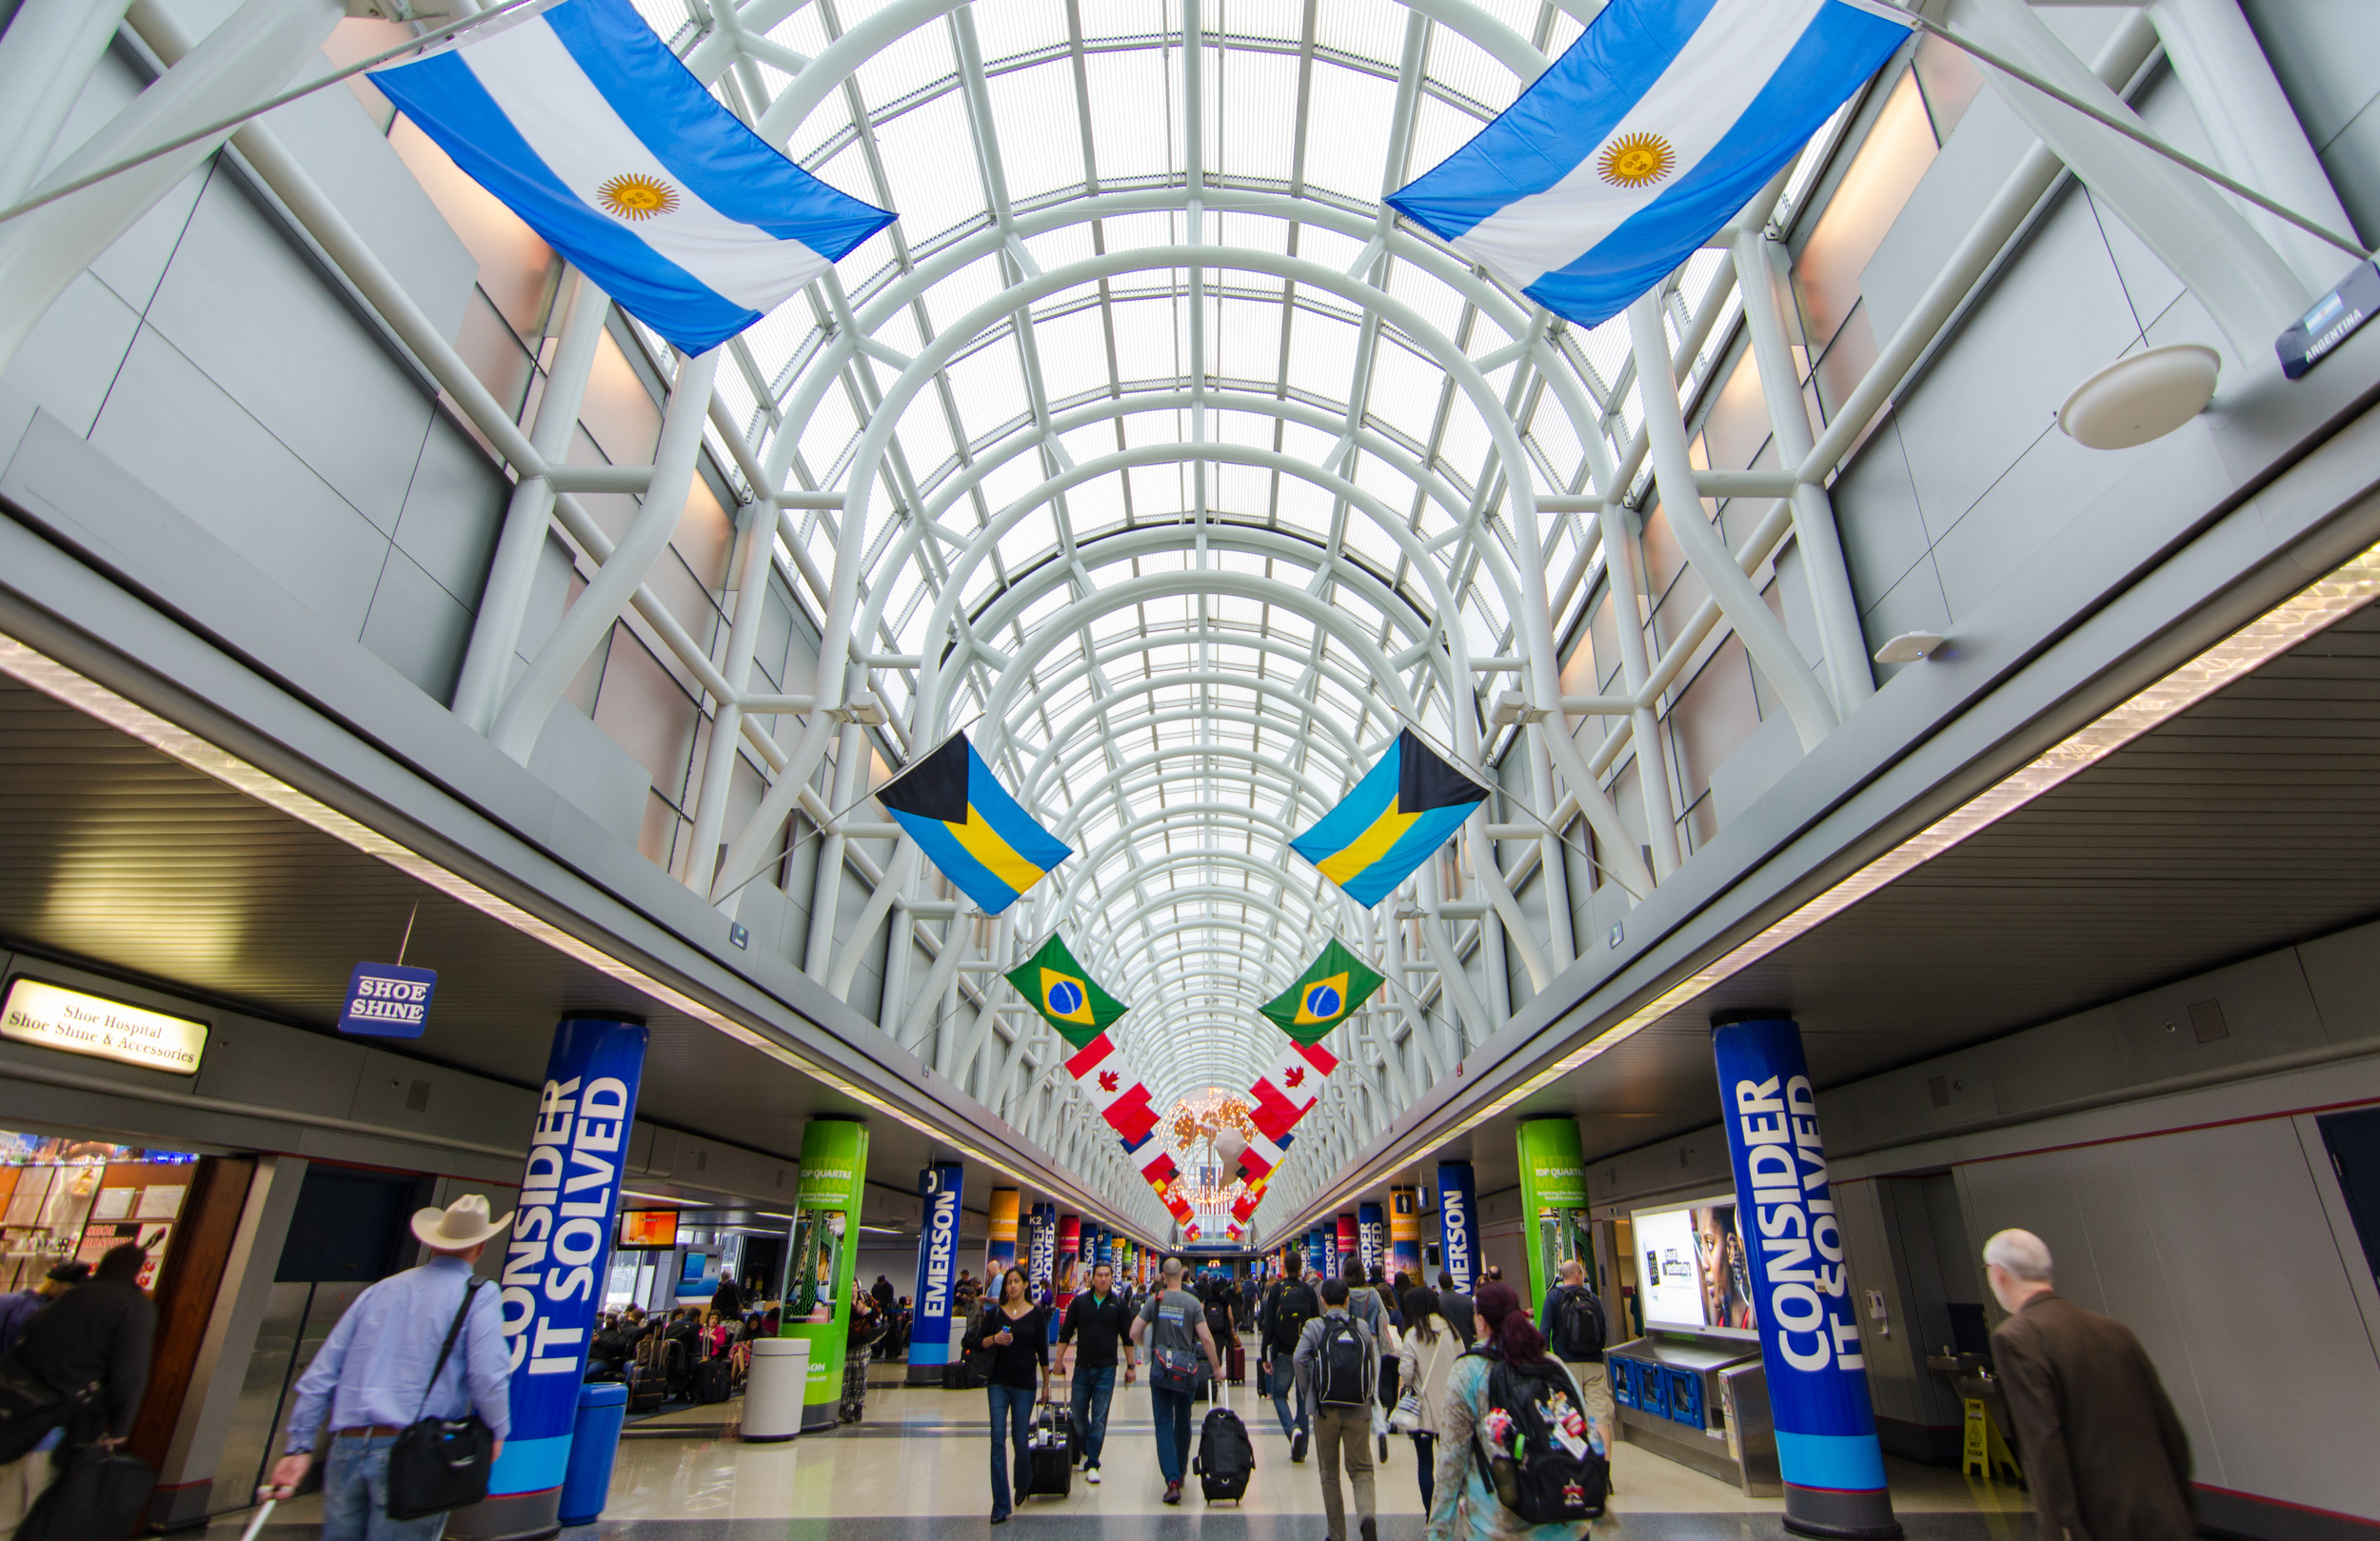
[1950, 0, 2309, 362]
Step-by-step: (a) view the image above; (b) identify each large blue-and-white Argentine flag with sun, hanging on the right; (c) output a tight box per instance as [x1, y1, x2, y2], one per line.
[1388, 0, 1909, 326]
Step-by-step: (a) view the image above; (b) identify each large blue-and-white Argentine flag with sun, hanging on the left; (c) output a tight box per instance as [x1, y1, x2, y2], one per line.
[371, 0, 893, 352]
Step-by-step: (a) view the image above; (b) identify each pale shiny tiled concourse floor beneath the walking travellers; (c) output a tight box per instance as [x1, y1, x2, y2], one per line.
[209, 1384, 2033, 1541]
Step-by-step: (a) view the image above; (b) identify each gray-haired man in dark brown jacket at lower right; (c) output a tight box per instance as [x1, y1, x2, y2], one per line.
[1983, 1230, 2197, 1541]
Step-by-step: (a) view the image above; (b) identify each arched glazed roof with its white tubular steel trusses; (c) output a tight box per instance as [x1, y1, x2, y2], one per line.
[0, 0, 2347, 1213]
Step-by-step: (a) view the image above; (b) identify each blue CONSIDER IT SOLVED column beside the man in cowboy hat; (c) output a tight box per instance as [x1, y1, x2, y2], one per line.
[488, 1017, 645, 1498]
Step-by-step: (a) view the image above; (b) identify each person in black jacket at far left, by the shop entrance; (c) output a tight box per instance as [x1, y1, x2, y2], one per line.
[0, 1241, 157, 1536]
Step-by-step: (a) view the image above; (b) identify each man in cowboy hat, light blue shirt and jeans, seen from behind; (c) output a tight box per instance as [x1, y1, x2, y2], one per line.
[269, 1194, 512, 1541]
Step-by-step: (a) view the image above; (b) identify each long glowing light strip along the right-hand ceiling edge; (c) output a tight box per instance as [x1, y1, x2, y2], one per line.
[1304, 544, 2380, 1213]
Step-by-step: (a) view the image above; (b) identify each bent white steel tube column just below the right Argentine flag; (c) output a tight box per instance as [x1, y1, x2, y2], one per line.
[1628, 295, 1835, 766]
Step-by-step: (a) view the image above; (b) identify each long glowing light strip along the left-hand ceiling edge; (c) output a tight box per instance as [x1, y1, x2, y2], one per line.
[0, 635, 1152, 1246]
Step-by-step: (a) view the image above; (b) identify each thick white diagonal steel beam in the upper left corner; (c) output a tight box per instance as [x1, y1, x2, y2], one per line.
[0, 0, 343, 368]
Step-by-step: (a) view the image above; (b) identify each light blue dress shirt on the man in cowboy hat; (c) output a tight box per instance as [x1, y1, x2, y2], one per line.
[288, 1258, 512, 1455]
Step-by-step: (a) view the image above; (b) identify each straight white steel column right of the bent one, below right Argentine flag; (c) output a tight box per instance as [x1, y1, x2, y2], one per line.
[1733, 228, 1875, 716]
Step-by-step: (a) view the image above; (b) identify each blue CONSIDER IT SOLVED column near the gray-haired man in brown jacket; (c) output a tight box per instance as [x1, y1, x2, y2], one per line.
[1712, 1013, 1902, 1539]
